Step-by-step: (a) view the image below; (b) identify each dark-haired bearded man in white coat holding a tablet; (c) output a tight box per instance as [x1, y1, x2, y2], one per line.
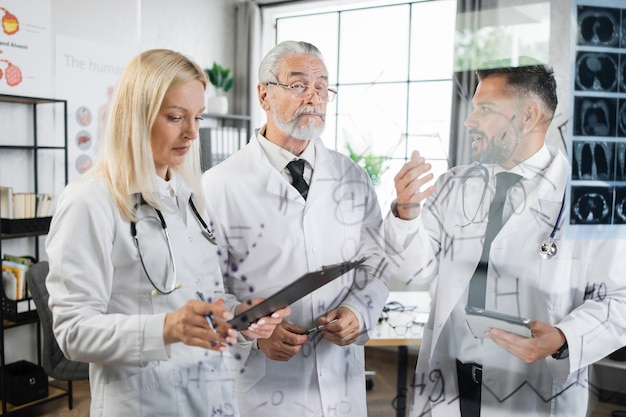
[385, 59, 626, 417]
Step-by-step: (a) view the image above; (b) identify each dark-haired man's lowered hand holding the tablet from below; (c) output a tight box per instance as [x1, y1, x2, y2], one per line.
[486, 321, 565, 363]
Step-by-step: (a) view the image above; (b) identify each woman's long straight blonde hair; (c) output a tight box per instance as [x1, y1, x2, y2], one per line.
[92, 49, 207, 221]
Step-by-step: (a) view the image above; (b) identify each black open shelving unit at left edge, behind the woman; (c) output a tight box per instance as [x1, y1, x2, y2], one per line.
[0, 94, 69, 416]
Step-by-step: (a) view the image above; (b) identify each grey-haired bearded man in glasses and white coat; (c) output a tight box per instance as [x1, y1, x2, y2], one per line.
[203, 41, 388, 417]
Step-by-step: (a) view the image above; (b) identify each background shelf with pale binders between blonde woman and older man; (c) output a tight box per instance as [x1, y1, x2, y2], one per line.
[199, 113, 252, 171]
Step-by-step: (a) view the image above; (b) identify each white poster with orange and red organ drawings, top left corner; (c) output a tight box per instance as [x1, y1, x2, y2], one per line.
[0, 0, 52, 97]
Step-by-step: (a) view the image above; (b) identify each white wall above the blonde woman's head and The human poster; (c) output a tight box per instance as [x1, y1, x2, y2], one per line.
[52, 0, 236, 75]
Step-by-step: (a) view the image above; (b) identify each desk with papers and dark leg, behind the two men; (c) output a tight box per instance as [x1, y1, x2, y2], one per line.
[365, 291, 430, 417]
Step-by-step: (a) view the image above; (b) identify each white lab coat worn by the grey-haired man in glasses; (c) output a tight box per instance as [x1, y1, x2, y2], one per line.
[203, 137, 388, 417]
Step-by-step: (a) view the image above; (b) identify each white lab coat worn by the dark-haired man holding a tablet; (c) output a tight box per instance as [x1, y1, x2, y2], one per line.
[385, 148, 626, 417]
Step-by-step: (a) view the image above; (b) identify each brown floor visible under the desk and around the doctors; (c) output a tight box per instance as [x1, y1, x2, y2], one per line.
[6, 347, 626, 417]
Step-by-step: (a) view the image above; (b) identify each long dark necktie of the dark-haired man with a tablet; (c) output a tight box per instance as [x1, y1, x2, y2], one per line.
[467, 172, 521, 308]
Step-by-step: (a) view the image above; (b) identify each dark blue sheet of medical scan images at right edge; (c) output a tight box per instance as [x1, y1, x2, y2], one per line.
[569, 0, 626, 236]
